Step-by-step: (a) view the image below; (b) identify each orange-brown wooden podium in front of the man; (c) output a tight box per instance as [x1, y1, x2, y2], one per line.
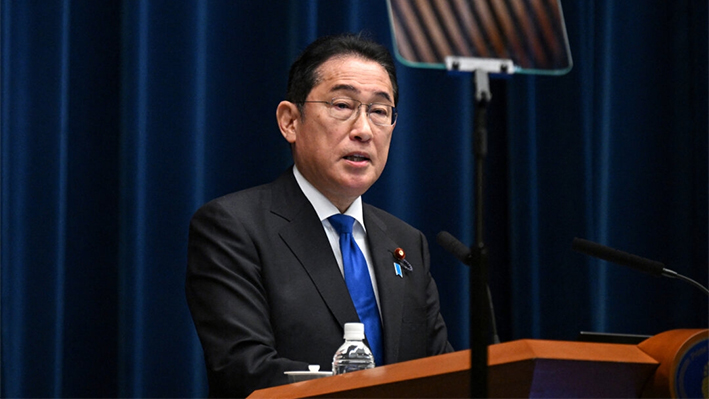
[249, 330, 709, 399]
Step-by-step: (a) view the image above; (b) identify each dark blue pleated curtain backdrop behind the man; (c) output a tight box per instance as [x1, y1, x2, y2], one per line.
[0, 0, 708, 397]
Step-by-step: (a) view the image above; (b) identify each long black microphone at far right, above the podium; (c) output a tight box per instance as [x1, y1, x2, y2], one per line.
[571, 237, 709, 295]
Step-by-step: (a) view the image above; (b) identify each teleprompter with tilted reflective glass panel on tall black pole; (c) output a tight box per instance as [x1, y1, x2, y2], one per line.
[387, 0, 571, 397]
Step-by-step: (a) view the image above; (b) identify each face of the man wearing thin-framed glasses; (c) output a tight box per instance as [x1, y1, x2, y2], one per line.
[284, 56, 394, 211]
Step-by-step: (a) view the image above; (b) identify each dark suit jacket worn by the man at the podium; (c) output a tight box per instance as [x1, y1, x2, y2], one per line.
[186, 169, 452, 396]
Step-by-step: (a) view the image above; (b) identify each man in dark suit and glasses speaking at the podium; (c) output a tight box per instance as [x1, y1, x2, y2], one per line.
[186, 35, 452, 396]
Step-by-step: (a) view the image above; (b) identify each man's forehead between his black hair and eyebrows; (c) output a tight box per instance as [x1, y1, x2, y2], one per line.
[313, 55, 393, 101]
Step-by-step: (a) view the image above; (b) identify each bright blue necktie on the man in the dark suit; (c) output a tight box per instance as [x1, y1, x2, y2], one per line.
[328, 214, 384, 366]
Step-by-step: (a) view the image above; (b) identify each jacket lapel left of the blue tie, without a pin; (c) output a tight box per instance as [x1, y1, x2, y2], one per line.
[271, 169, 358, 327]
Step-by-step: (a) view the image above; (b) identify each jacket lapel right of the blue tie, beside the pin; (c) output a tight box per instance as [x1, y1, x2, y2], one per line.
[364, 206, 406, 363]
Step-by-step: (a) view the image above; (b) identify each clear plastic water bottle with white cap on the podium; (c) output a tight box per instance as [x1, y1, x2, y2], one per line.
[332, 323, 374, 375]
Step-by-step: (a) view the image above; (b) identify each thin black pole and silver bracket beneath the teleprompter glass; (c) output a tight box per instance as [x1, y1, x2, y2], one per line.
[446, 56, 514, 398]
